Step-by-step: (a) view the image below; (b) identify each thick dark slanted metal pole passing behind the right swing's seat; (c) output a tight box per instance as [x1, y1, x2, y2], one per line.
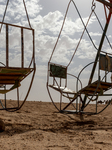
[81, 10, 112, 110]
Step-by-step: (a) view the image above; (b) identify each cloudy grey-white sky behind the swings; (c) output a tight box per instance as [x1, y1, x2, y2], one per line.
[0, 0, 112, 101]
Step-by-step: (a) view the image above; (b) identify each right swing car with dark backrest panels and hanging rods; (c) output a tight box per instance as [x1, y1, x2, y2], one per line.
[46, 0, 112, 115]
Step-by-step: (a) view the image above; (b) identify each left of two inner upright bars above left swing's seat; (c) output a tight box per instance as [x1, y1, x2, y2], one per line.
[6, 25, 9, 67]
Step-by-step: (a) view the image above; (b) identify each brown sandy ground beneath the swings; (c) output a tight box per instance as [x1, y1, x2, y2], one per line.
[0, 101, 112, 150]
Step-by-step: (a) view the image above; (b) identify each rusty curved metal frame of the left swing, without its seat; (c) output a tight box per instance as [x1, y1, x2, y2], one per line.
[0, 0, 36, 112]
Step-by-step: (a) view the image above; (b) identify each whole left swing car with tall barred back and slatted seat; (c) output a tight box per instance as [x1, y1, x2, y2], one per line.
[0, 0, 36, 112]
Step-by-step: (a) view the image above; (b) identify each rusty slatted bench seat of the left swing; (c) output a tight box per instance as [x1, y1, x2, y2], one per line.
[0, 67, 33, 94]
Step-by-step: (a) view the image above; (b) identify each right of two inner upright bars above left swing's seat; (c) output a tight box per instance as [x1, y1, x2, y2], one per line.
[21, 28, 24, 68]
